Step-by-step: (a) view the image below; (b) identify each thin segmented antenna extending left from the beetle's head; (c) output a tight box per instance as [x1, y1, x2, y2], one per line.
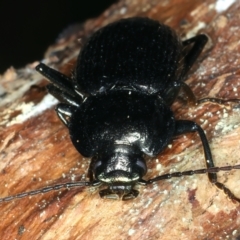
[0, 181, 95, 203]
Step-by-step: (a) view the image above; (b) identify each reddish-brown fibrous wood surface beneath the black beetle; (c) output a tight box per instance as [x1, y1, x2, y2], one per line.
[0, 0, 240, 240]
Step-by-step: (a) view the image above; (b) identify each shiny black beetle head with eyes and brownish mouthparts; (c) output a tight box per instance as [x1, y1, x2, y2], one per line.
[91, 145, 147, 200]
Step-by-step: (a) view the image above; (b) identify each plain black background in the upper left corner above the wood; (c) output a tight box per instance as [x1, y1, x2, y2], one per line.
[0, 0, 117, 74]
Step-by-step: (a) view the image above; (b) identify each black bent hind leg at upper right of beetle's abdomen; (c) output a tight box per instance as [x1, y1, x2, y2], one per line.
[182, 34, 208, 77]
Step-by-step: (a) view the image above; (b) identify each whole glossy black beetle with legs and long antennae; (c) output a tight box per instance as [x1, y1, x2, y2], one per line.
[0, 18, 240, 201]
